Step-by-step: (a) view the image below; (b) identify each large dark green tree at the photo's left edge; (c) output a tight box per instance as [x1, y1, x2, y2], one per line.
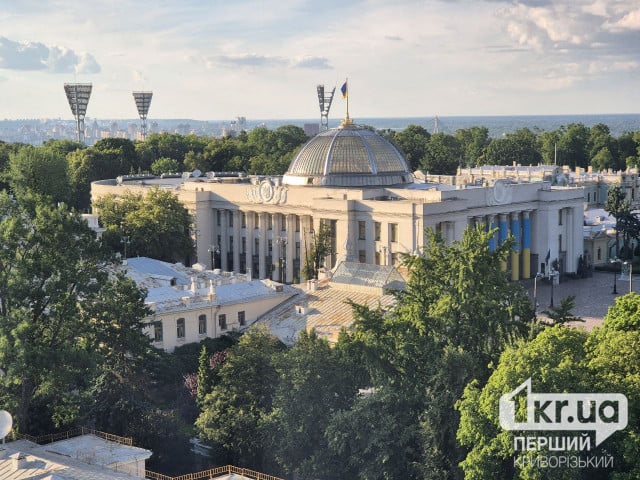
[0, 194, 111, 432]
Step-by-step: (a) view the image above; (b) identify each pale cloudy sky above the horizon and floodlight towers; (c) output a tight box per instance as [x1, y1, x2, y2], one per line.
[0, 0, 640, 120]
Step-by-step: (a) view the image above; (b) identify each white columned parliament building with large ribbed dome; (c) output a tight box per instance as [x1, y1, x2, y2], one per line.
[91, 118, 584, 283]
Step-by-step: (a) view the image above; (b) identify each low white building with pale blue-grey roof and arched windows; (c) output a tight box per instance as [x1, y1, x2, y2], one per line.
[123, 257, 295, 352]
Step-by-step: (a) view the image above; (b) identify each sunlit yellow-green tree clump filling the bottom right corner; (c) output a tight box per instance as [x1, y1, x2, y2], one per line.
[458, 293, 640, 480]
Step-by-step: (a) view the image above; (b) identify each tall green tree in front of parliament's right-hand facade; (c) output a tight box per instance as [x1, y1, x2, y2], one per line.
[326, 229, 535, 478]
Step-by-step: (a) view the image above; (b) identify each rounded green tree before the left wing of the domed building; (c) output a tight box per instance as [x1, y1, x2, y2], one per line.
[93, 188, 193, 262]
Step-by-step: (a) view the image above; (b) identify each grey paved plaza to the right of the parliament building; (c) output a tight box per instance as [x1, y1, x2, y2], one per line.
[524, 272, 640, 329]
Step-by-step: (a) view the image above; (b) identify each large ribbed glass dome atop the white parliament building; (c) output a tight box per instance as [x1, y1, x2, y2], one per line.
[283, 124, 413, 187]
